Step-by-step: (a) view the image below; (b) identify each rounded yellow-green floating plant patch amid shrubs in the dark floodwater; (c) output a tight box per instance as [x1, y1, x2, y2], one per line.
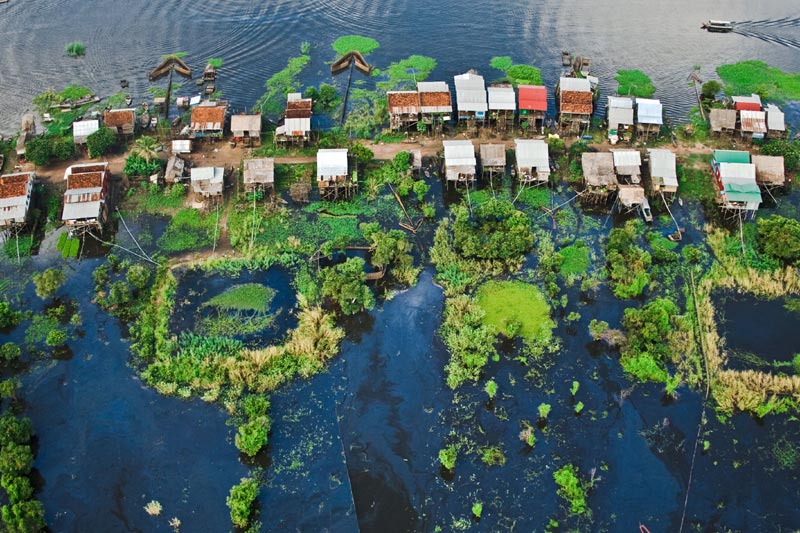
[475, 281, 555, 340]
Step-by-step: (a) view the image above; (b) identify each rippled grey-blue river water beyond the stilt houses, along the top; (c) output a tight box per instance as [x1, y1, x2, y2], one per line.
[0, 0, 800, 134]
